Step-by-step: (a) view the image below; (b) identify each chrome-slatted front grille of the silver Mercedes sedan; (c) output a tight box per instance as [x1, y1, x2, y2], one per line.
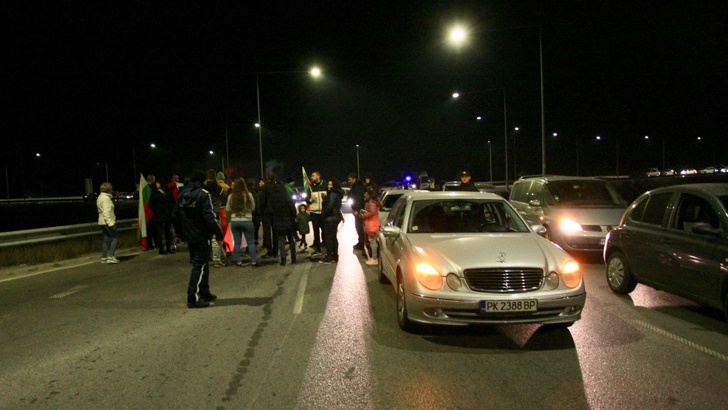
[465, 268, 543, 293]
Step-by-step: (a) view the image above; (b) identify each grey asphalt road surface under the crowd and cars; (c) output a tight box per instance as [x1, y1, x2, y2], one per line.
[0, 215, 728, 409]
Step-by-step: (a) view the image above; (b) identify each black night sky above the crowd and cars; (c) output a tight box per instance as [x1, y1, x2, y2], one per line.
[5, 0, 728, 198]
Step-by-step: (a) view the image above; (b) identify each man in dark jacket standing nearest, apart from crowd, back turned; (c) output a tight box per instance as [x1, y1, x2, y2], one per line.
[173, 171, 223, 308]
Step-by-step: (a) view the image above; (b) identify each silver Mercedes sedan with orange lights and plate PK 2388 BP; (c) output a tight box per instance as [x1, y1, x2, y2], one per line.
[378, 191, 586, 331]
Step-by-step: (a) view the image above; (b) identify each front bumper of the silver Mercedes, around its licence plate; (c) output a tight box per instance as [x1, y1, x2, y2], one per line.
[407, 293, 586, 325]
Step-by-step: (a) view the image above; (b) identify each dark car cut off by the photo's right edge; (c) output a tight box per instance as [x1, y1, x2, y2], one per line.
[604, 183, 728, 314]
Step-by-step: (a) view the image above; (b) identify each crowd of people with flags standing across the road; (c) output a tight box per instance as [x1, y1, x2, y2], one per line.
[97, 169, 390, 308]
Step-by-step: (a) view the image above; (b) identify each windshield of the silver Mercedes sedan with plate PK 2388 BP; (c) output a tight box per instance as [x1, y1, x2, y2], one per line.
[408, 199, 530, 233]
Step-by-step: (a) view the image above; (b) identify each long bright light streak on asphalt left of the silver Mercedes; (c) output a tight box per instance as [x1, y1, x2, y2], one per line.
[296, 214, 376, 409]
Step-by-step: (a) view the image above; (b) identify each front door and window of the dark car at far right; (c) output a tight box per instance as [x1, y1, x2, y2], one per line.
[659, 192, 728, 306]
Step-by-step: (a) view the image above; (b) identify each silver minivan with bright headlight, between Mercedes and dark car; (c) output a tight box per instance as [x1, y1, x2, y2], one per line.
[510, 176, 627, 256]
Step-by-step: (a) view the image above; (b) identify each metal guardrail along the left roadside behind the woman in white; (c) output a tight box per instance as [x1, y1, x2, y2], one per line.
[0, 218, 137, 248]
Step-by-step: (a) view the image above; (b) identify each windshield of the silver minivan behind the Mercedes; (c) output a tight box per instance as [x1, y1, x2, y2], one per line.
[544, 180, 621, 206]
